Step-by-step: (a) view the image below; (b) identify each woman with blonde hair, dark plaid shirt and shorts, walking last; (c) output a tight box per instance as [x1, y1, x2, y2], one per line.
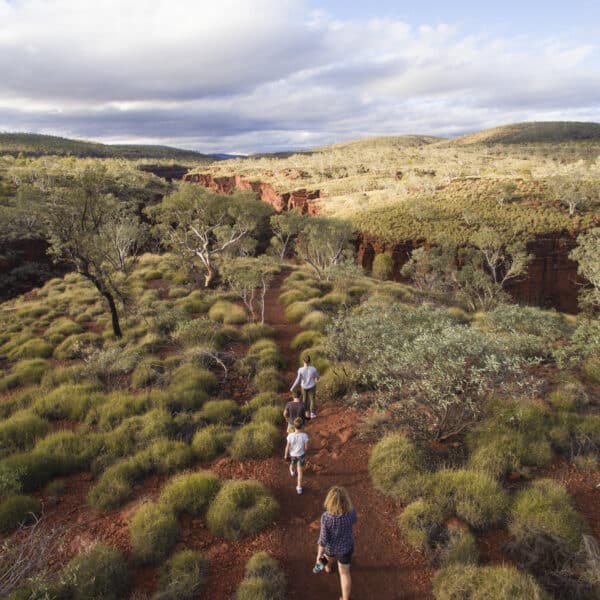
[317, 485, 356, 600]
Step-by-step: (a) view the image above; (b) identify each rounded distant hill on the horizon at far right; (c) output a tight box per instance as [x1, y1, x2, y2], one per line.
[445, 121, 600, 146]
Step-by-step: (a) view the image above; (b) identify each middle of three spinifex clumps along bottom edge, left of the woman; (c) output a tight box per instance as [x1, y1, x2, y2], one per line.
[152, 550, 208, 600]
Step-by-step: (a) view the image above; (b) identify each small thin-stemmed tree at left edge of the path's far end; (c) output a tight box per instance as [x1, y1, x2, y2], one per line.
[221, 256, 277, 324]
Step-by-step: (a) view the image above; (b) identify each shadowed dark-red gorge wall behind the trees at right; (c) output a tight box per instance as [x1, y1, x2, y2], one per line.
[357, 235, 582, 313]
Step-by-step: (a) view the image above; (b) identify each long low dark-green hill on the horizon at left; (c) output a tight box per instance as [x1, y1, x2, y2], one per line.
[0, 133, 215, 163]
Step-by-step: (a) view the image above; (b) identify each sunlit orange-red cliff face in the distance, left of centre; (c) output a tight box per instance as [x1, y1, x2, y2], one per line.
[183, 173, 321, 215]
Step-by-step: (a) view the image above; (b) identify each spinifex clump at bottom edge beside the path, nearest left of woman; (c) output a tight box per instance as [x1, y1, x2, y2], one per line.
[235, 552, 286, 600]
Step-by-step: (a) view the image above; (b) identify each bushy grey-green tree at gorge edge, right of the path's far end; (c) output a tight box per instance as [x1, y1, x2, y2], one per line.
[296, 217, 353, 279]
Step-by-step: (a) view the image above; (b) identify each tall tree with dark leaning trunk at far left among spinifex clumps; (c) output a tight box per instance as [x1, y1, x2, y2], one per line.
[44, 166, 147, 337]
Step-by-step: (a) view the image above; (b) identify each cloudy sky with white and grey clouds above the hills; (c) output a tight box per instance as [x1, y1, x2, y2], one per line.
[0, 0, 600, 153]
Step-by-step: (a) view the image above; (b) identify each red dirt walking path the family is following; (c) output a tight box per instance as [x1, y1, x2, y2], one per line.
[246, 276, 432, 600]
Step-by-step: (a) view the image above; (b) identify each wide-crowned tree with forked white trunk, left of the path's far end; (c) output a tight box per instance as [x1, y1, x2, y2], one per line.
[147, 183, 273, 287]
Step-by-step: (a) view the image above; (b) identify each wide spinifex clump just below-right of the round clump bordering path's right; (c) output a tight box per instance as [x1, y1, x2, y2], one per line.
[429, 469, 509, 529]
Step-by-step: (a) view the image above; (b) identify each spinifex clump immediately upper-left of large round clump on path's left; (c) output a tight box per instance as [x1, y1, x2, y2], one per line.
[159, 471, 221, 516]
